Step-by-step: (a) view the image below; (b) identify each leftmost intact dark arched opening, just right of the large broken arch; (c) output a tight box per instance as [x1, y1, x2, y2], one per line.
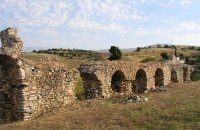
[111, 70, 125, 93]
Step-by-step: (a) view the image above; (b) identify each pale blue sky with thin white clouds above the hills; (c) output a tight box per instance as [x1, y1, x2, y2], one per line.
[0, 0, 200, 50]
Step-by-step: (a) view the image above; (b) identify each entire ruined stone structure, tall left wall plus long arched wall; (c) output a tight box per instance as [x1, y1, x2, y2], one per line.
[0, 28, 193, 123]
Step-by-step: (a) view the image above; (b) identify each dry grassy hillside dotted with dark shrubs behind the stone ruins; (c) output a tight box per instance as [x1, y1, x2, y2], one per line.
[25, 45, 200, 78]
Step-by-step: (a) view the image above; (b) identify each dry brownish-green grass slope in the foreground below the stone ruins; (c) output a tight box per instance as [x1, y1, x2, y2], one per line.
[0, 81, 200, 130]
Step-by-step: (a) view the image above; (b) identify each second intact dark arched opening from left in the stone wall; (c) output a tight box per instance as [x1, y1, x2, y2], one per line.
[132, 69, 147, 93]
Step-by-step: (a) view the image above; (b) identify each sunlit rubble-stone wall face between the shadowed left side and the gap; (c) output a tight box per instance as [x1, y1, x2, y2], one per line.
[20, 59, 78, 119]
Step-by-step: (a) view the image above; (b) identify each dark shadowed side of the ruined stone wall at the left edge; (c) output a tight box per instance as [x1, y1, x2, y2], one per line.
[0, 54, 25, 123]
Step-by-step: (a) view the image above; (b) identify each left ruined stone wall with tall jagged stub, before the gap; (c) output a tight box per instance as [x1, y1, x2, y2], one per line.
[0, 28, 79, 123]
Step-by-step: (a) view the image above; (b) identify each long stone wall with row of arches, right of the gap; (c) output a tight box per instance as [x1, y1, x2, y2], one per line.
[79, 57, 193, 98]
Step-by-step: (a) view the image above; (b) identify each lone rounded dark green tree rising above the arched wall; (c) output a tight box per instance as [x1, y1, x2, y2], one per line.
[108, 46, 122, 60]
